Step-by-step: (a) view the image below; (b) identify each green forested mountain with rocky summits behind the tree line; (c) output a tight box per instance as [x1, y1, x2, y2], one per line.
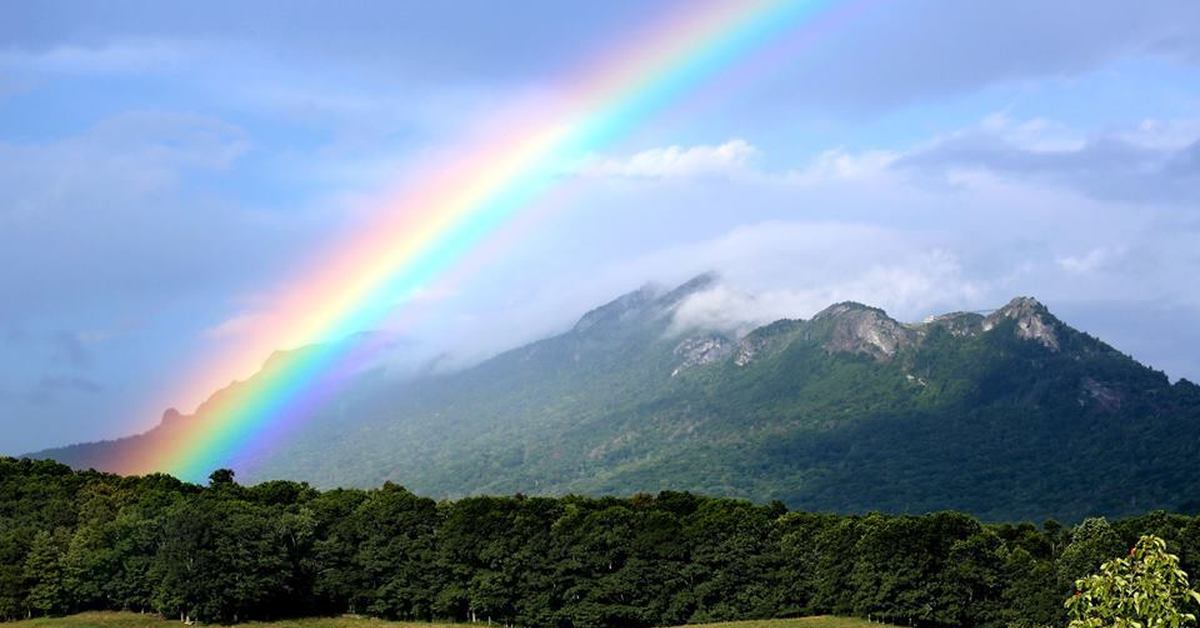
[35, 275, 1200, 520]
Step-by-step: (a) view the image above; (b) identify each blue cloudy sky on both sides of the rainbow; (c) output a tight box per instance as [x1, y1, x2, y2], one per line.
[0, 0, 1200, 454]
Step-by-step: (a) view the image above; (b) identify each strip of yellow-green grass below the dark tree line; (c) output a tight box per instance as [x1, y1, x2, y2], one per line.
[6, 612, 872, 628]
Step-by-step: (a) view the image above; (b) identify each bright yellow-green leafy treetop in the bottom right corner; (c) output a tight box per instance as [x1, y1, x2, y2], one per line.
[1066, 534, 1200, 628]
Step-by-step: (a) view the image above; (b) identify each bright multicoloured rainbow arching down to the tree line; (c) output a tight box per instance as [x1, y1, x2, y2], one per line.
[119, 0, 832, 480]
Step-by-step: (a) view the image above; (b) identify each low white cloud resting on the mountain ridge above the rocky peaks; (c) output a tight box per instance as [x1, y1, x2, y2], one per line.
[657, 228, 991, 331]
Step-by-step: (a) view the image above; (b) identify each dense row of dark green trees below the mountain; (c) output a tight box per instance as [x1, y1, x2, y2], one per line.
[0, 459, 1200, 627]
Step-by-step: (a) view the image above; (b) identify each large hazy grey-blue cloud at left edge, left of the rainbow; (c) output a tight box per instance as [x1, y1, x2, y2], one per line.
[0, 112, 266, 328]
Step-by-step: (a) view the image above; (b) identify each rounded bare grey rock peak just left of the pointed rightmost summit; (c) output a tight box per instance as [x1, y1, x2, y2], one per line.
[812, 301, 916, 360]
